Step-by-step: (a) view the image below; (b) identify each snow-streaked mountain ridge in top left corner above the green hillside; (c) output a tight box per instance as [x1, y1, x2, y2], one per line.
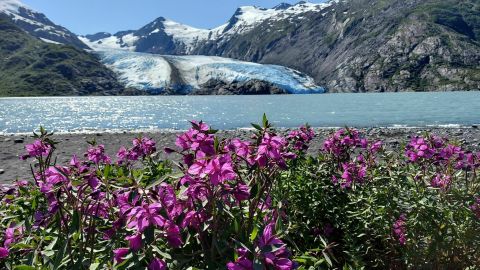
[0, 0, 88, 49]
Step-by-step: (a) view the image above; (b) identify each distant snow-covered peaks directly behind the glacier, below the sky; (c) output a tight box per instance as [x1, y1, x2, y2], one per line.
[80, 1, 335, 55]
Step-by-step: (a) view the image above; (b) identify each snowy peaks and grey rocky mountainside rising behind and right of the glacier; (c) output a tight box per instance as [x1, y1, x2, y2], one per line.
[83, 0, 480, 92]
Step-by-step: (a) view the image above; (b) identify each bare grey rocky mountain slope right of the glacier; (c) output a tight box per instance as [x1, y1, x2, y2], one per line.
[227, 0, 480, 92]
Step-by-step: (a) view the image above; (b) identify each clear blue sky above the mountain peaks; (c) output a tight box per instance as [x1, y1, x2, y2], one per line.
[20, 0, 325, 35]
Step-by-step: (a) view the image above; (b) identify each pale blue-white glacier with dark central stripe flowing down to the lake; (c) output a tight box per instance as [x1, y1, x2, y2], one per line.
[94, 50, 325, 94]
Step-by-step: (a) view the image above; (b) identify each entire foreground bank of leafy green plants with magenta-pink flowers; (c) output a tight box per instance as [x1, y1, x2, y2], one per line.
[0, 116, 480, 269]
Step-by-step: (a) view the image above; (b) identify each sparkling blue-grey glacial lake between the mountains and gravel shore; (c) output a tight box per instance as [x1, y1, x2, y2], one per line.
[0, 92, 480, 134]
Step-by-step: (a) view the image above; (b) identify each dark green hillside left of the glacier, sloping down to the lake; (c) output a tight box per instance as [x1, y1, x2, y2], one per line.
[0, 19, 124, 96]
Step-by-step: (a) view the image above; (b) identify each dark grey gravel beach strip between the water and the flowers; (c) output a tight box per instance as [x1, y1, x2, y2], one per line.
[0, 127, 480, 183]
